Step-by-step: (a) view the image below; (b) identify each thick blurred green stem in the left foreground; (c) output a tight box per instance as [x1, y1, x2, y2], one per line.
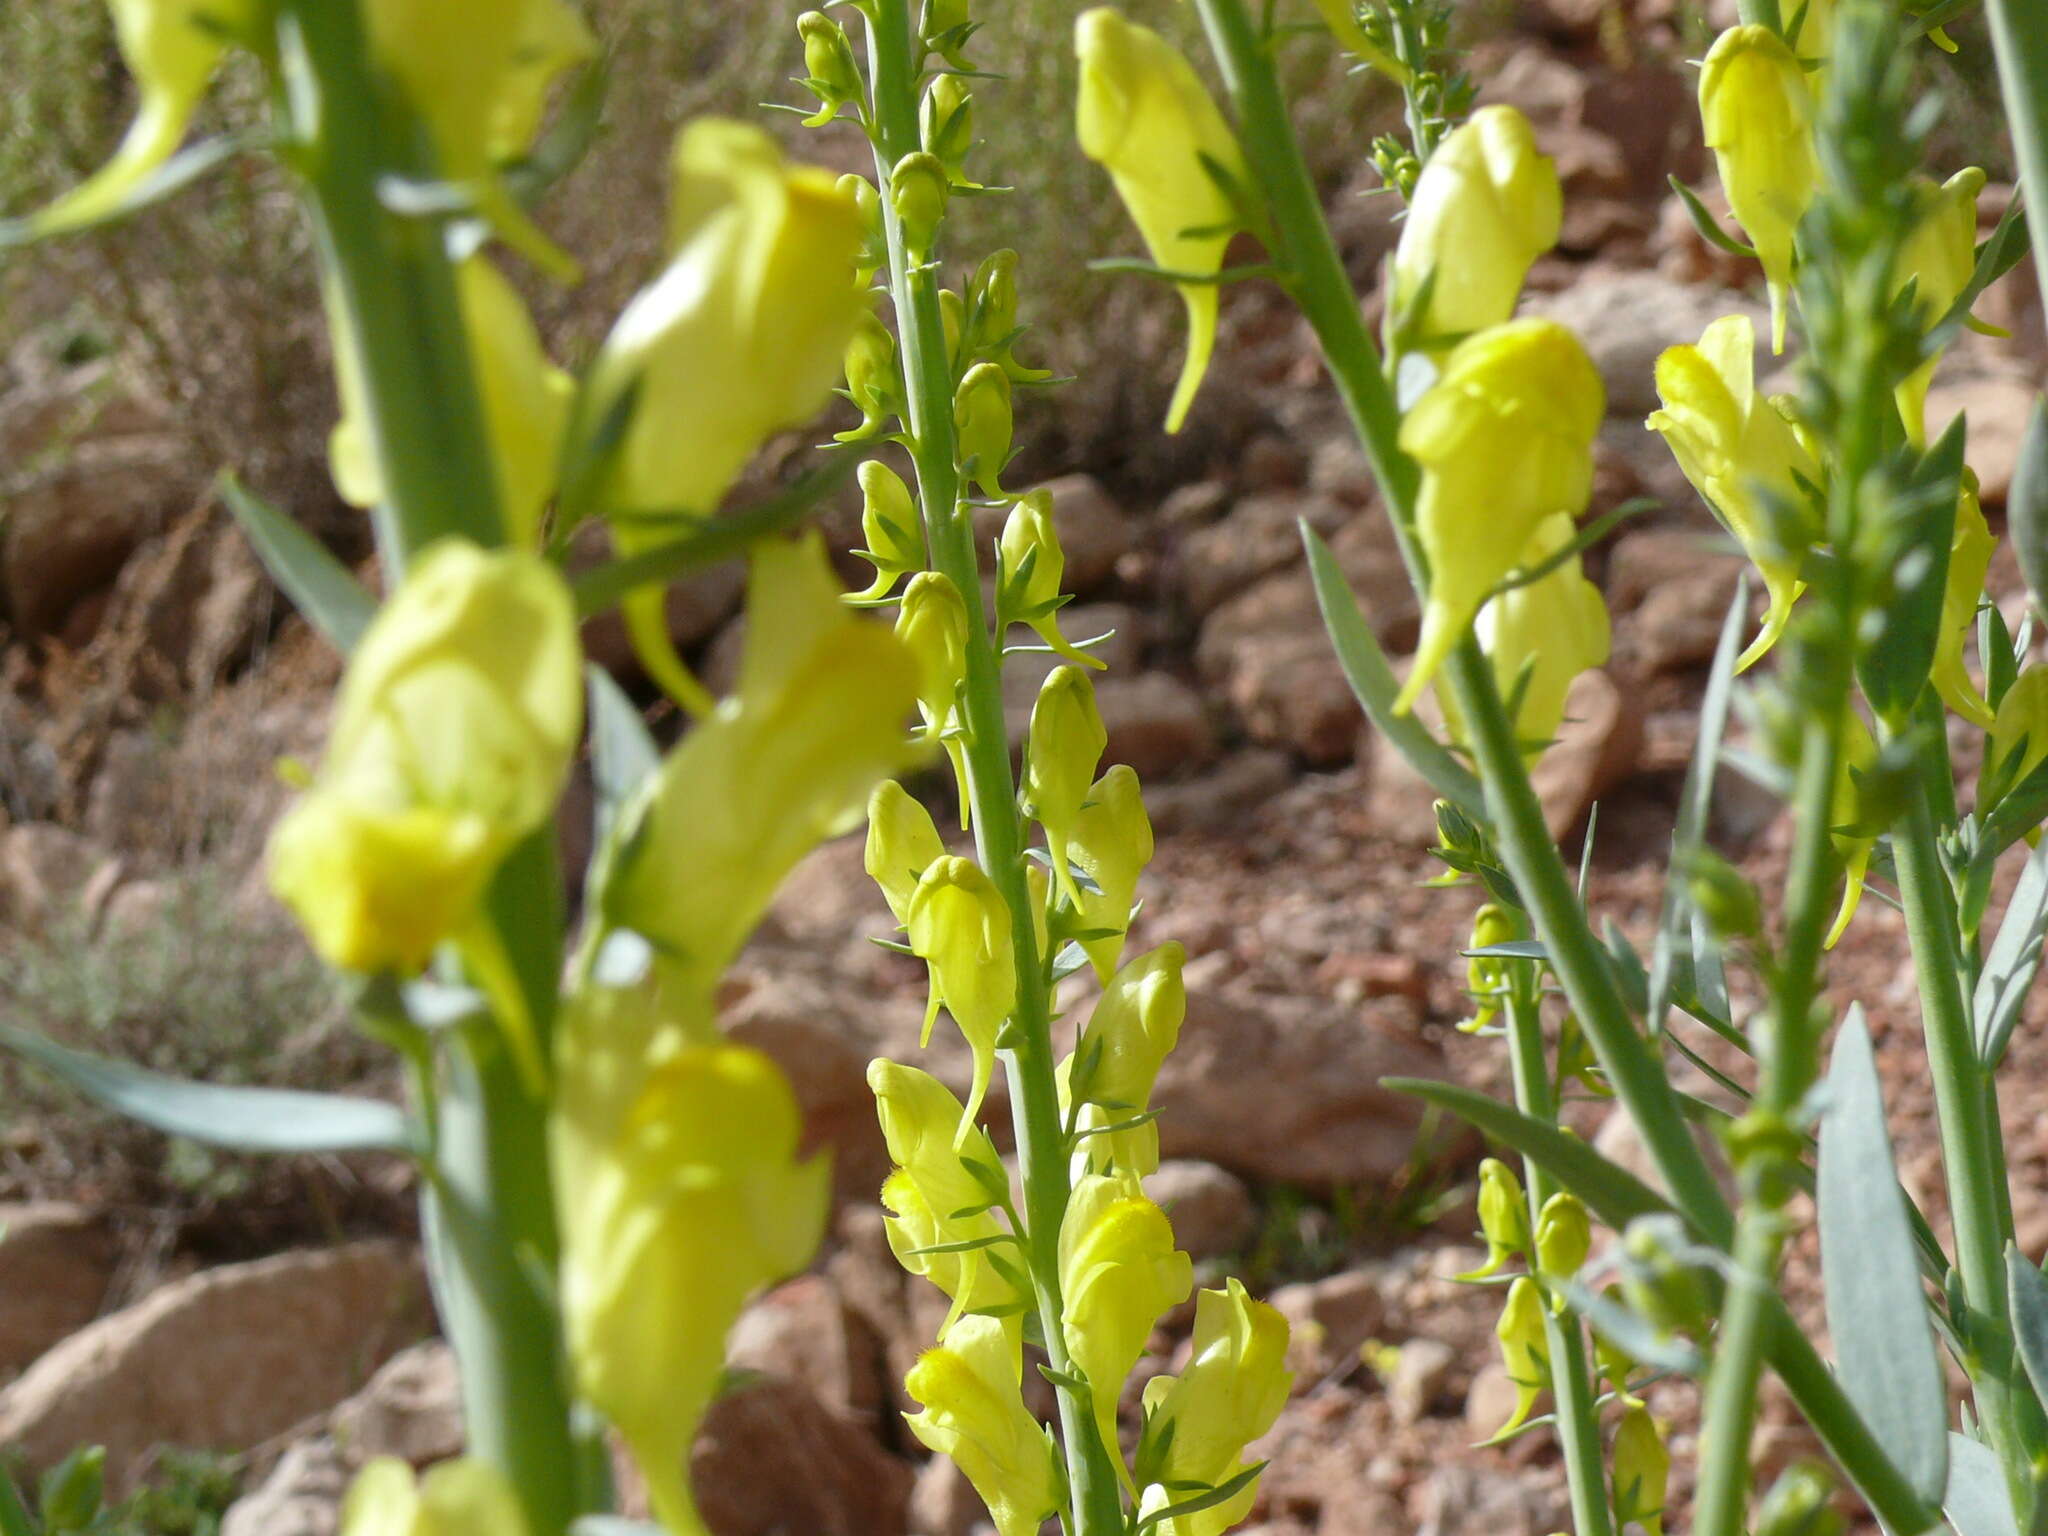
[279, 0, 588, 1532]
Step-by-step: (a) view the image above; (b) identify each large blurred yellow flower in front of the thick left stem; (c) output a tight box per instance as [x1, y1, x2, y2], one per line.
[268, 541, 584, 973]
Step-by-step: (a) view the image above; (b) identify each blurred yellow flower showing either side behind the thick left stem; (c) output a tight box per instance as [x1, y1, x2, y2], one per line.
[328, 256, 575, 549]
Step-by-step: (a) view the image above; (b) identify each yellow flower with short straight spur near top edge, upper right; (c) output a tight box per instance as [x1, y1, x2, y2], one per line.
[1700, 27, 1821, 352]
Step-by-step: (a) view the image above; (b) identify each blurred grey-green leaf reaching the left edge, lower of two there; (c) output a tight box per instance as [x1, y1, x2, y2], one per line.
[0, 1024, 418, 1153]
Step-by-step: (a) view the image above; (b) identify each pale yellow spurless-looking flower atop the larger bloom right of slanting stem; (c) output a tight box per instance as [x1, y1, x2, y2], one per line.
[1393, 106, 1565, 346]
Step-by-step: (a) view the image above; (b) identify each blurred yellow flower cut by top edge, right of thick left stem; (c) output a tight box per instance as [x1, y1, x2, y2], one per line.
[362, 0, 598, 283]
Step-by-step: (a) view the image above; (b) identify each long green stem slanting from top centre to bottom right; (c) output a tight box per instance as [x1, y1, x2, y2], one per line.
[1196, 0, 1935, 1532]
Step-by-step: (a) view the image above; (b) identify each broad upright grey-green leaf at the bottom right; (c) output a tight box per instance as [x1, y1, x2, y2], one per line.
[1815, 1008, 1948, 1503]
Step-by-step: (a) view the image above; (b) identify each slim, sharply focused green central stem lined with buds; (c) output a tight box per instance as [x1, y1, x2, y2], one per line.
[868, 12, 1124, 1536]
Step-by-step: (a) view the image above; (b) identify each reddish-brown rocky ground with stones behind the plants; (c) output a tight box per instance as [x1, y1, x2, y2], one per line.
[0, 0, 2048, 1536]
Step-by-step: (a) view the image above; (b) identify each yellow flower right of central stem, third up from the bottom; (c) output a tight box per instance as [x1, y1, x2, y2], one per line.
[1059, 942, 1188, 1176]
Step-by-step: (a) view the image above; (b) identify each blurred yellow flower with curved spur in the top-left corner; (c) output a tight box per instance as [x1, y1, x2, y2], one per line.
[13, 0, 256, 236]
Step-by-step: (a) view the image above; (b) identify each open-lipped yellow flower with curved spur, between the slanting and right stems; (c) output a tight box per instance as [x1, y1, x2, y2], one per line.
[1645, 315, 1821, 672]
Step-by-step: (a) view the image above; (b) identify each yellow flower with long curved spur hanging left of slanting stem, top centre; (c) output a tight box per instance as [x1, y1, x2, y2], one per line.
[1073, 6, 1251, 432]
